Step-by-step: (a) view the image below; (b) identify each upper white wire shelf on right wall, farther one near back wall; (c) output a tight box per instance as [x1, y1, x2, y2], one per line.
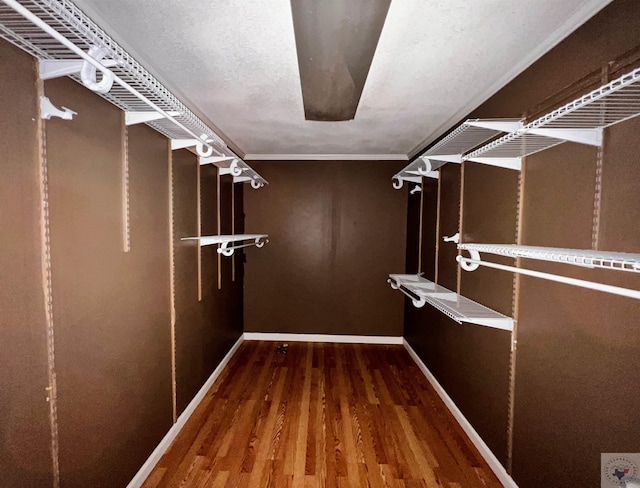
[393, 119, 522, 189]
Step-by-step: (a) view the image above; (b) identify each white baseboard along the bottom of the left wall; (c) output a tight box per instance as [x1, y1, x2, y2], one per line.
[127, 336, 244, 488]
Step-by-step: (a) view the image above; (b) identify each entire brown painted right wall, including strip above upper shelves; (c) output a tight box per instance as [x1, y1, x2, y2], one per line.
[405, 0, 640, 488]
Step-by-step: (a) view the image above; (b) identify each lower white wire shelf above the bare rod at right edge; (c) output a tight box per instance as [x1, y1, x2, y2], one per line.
[458, 243, 640, 273]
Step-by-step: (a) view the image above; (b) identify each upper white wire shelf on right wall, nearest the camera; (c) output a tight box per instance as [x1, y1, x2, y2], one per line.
[463, 68, 640, 169]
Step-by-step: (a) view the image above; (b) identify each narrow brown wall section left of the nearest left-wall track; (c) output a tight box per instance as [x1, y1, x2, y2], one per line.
[0, 42, 53, 488]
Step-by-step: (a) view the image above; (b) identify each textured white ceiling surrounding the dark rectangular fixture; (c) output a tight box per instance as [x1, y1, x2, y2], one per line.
[75, 0, 611, 159]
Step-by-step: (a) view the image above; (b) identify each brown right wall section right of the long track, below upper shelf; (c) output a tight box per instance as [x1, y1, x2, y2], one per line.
[514, 120, 640, 486]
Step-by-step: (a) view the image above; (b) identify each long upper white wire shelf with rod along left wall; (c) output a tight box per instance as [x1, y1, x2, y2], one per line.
[0, 0, 266, 186]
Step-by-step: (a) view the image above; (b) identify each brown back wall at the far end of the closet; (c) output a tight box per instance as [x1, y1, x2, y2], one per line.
[245, 161, 407, 336]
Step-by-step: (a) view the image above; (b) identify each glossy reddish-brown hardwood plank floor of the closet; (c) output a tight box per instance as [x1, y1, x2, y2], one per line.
[143, 341, 501, 488]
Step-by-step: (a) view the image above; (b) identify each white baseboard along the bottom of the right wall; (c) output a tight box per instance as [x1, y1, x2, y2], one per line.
[403, 339, 518, 488]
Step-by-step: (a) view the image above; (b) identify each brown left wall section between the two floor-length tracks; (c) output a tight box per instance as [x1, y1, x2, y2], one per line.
[45, 79, 171, 487]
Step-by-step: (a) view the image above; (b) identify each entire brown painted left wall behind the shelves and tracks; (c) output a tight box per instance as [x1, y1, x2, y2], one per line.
[0, 37, 242, 488]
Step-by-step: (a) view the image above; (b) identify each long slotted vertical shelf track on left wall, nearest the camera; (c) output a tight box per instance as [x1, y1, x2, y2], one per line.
[35, 76, 60, 488]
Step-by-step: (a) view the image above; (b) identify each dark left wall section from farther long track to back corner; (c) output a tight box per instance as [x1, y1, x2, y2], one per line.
[172, 159, 242, 415]
